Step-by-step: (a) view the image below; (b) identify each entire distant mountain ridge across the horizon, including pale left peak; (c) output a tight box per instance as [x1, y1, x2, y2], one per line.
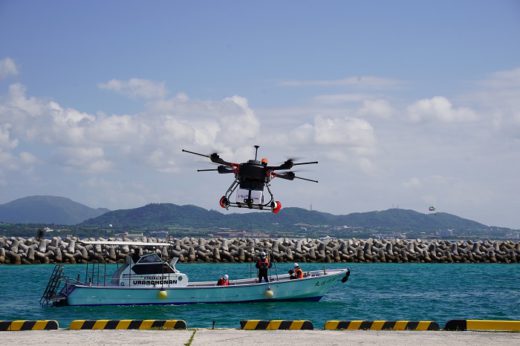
[0, 196, 520, 238]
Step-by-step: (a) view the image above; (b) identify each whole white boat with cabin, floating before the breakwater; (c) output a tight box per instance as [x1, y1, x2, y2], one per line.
[41, 246, 350, 306]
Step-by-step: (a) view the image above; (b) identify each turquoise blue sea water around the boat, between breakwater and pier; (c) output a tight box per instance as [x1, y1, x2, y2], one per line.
[0, 263, 520, 328]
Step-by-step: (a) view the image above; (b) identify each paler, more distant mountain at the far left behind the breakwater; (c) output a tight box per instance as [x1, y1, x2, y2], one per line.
[0, 196, 109, 225]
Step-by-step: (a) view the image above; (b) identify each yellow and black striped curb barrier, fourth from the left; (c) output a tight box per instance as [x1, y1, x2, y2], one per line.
[324, 320, 439, 330]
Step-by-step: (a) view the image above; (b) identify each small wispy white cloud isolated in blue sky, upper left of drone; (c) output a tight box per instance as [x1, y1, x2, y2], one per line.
[98, 78, 167, 99]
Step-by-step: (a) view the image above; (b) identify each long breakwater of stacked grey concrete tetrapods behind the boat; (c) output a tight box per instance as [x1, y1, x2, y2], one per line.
[0, 237, 520, 264]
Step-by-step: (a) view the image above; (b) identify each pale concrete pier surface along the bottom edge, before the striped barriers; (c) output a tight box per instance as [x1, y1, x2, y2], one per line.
[0, 329, 520, 346]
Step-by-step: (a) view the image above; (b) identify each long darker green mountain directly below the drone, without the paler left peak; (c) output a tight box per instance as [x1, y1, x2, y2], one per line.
[79, 203, 506, 236]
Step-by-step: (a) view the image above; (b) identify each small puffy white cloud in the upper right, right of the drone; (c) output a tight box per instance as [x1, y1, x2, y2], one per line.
[407, 96, 477, 123]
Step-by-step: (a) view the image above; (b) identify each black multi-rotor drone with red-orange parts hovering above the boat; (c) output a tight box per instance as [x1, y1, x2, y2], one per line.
[182, 145, 318, 214]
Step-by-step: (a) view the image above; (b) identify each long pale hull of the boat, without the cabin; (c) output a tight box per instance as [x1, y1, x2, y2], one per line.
[66, 269, 348, 306]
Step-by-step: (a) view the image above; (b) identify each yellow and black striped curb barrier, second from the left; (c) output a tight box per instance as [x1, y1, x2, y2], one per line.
[69, 320, 186, 330]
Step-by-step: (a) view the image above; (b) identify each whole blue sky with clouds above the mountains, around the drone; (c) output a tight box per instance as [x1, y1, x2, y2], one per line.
[0, 0, 520, 228]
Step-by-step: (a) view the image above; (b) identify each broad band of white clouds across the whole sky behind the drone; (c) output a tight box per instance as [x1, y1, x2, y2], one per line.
[0, 64, 520, 227]
